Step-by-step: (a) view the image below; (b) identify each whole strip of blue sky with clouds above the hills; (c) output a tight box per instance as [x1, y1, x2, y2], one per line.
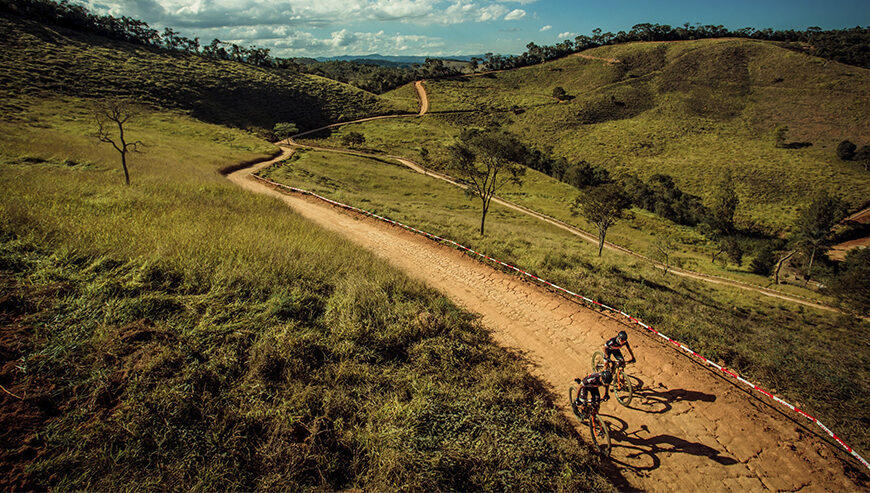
[83, 0, 870, 57]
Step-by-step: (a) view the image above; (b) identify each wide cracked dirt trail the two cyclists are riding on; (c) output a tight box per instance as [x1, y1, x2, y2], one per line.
[228, 152, 868, 491]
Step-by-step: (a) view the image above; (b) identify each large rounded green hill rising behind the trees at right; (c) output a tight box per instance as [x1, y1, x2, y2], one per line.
[414, 39, 870, 231]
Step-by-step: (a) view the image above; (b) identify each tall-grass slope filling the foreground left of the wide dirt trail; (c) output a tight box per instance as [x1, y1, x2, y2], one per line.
[0, 98, 609, 490]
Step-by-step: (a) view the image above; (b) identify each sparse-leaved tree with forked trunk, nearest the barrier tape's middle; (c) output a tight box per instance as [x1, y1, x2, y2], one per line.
[447, 128, 527, 236]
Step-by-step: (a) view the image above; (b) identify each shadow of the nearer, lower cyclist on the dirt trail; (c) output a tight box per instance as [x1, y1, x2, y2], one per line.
[599, 414, 738, 472]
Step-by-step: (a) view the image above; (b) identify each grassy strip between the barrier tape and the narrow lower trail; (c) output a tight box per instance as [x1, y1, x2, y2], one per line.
[264, 152, 870, 458]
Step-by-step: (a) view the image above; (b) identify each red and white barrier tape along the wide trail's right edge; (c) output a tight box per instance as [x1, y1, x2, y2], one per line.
[252, 175, 870, 470]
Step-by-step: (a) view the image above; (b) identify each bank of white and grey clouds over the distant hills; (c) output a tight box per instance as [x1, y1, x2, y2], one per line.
[85, 0, 536, 56]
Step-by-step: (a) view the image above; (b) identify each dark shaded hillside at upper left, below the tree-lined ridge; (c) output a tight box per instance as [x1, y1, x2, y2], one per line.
[0, 16, 408, 129]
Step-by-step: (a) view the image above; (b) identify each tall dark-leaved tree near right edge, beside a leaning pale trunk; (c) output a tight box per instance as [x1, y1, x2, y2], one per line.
[790, 191, 846, 282]
